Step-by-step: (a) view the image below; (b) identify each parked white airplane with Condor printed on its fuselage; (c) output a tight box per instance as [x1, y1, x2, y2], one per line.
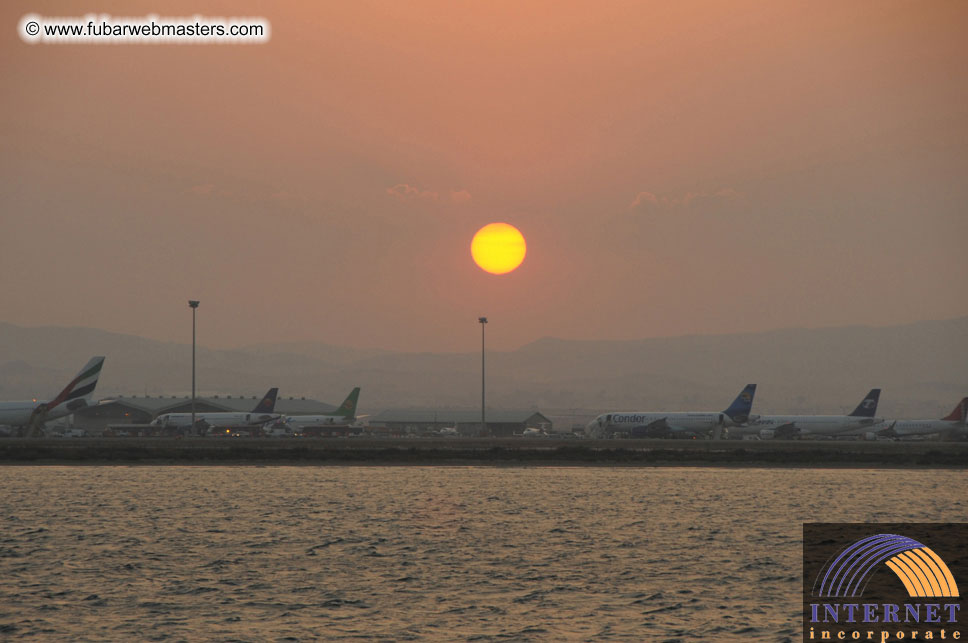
[585, 384, 756, 438]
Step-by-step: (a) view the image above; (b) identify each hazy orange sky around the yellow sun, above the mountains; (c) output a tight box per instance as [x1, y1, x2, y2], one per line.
[0, 0, 968, 351]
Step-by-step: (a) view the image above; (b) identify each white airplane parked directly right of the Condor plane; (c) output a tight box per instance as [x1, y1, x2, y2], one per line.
[734, 388, 884, 439]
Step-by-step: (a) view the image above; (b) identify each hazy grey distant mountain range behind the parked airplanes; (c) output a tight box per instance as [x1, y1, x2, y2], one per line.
[0, 317, 968, 421]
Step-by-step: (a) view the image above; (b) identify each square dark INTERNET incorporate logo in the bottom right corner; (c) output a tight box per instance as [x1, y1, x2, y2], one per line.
[803, 523, 968, 643]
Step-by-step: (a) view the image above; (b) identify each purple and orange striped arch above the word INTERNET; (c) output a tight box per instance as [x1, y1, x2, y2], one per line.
[814, 534, 959, 598]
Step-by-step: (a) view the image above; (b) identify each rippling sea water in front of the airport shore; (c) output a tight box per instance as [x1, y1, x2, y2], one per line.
[0, 466, 968, 641]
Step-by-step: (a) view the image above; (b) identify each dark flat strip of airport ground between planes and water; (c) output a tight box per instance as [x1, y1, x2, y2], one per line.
[0, 438, 968, 468]
